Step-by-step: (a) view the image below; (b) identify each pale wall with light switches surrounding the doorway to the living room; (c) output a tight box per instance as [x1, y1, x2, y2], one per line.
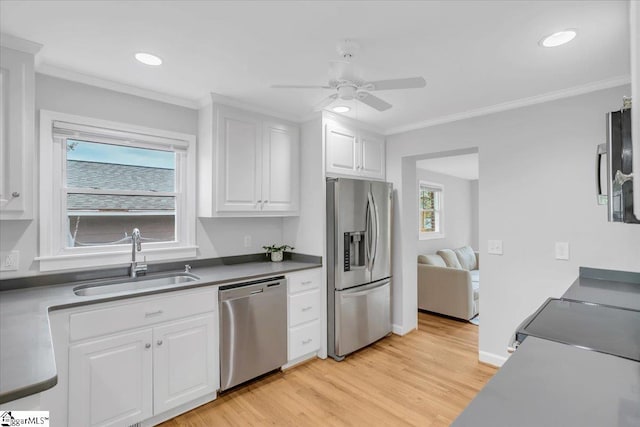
[387, 86, 640, 363]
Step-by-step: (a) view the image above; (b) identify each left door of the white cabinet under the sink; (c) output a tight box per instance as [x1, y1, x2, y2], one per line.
[69, 329, 153, 427]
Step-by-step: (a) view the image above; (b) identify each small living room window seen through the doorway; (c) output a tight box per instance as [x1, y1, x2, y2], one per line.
[418, 181, 444, 240]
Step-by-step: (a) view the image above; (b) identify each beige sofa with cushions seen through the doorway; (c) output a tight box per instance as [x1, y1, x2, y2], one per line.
[418, 246, 480, 320]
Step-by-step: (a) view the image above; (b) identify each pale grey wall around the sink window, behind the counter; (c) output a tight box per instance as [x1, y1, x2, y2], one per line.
[0, 74, 283, 279]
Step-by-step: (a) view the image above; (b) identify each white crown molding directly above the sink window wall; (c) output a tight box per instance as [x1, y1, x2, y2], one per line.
[36, 63, 199, 110]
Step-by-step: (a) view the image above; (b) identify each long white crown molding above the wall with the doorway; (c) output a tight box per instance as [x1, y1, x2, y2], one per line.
[385, 75, 631, 136]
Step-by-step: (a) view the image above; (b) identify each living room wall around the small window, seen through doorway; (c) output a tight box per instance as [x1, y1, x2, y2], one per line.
[416, 168, 474, 254]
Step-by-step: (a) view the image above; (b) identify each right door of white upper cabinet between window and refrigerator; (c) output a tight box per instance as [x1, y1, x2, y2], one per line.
[262, 121, 300, 212]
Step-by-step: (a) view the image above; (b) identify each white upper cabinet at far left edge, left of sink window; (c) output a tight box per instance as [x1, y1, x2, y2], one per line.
[0, 34, 41, 219]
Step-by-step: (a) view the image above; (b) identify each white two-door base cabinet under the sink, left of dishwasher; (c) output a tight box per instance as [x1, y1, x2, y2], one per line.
[67, 289, 219, 427]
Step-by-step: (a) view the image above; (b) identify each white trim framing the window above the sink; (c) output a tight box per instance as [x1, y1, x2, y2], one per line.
[35, 110, 197, 271]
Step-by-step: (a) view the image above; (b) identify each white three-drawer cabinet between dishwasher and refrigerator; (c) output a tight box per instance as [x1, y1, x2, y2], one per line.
[287, 268, 322, 364]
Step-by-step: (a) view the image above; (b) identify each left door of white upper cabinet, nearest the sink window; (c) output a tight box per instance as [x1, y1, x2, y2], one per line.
[216, 108, 262, 212]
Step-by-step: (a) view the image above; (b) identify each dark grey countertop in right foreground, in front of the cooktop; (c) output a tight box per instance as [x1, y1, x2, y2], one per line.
[452, 337, 640, 427]
